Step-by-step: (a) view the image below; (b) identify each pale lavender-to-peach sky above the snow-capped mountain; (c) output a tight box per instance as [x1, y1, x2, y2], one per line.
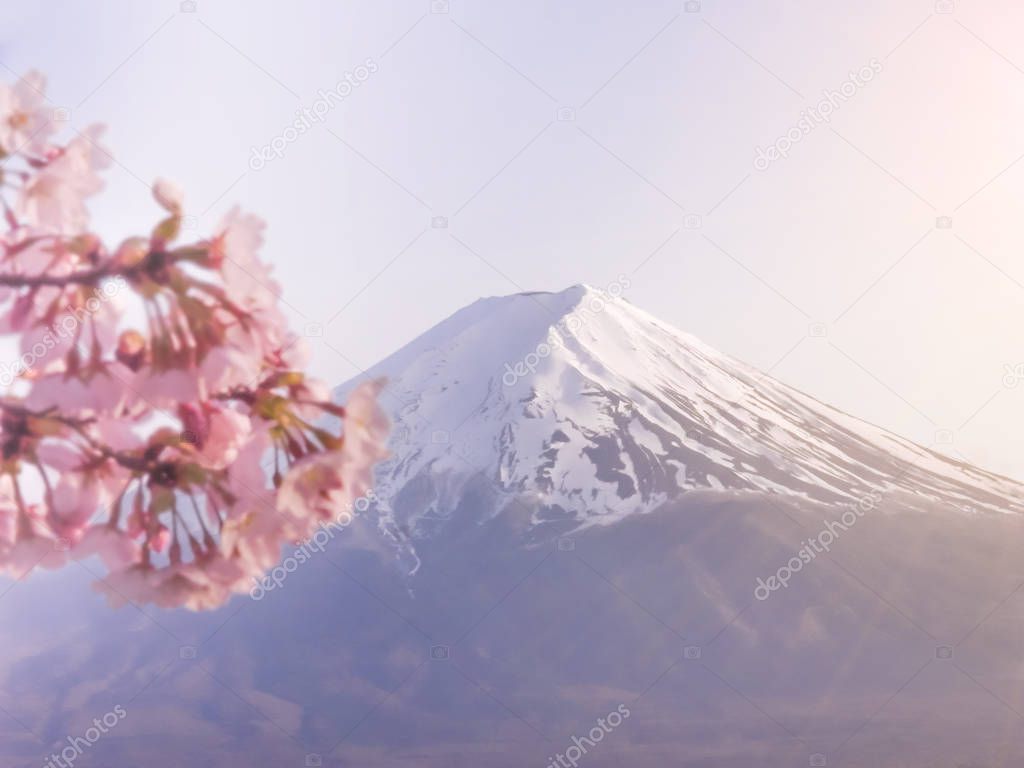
[0, 0, 1024, 479]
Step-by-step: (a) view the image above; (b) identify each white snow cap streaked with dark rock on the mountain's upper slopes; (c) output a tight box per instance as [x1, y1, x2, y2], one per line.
[339, 286, 1024, 539]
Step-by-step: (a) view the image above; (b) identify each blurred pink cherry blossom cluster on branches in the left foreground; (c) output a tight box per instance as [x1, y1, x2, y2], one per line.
[0, 74, 388, 609]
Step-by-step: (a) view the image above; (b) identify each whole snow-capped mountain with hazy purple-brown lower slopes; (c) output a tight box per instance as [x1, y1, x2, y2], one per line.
[0, 286, 1024, 768]
